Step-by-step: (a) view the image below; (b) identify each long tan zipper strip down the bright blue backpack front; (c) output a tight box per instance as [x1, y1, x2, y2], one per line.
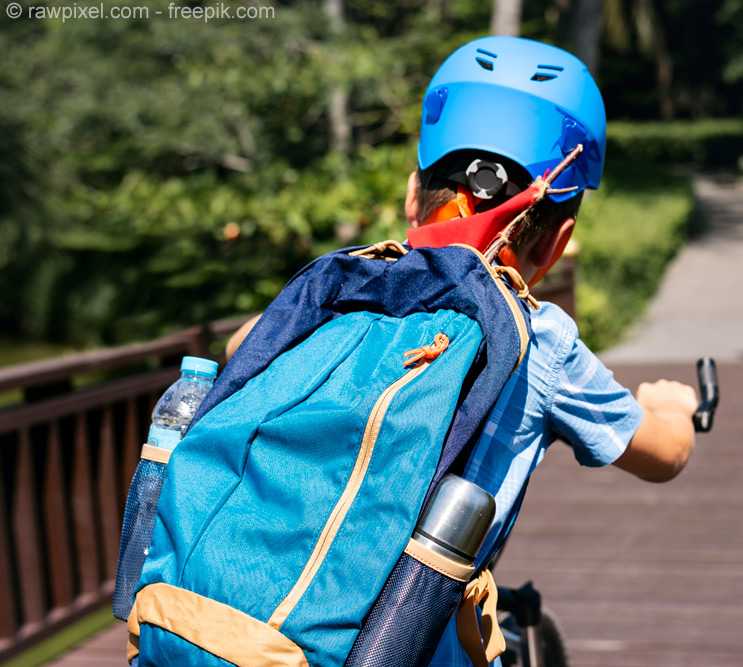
[268, 359, 434, 630]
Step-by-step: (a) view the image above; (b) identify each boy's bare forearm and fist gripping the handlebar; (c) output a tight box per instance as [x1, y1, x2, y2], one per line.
[614, 380, 697, 482]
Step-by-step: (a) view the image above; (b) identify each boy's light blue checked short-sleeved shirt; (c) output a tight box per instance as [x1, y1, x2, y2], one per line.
[431, 302, 642, 667]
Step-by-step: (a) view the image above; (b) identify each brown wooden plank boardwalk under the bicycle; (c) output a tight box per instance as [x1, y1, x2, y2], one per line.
[52, 362, 743, 667]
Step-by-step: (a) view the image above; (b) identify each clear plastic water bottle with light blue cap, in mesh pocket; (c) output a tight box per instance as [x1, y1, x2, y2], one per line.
[113, 357, 217, 621]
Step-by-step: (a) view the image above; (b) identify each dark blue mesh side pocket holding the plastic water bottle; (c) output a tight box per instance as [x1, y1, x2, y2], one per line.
[113, 459, 166, 621]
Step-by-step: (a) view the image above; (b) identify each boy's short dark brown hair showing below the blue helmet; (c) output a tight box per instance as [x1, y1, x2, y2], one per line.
[416, 151, 583, 250]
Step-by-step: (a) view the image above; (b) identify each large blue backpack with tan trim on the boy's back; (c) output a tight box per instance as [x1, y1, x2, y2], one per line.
[128, 242, 531, 667]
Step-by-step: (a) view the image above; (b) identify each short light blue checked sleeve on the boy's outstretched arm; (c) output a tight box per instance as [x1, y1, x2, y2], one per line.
[549, 338, 642, 467]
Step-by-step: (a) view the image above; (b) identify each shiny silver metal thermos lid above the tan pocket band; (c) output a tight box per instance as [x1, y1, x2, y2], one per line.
[415, 474, 495, 562]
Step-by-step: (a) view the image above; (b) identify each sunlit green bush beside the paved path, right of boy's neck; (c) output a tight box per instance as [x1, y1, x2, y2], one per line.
[575, 161, 694, 350]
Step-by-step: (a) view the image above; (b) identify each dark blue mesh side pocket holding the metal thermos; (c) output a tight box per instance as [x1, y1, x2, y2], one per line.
[345, 554, 467, 667]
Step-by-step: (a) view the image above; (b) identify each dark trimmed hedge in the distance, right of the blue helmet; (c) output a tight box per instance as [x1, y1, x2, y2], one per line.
[606, 118, 743, 167]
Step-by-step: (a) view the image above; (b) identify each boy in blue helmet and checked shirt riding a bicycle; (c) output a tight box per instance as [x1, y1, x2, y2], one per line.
[228, 37, 697, 667]
